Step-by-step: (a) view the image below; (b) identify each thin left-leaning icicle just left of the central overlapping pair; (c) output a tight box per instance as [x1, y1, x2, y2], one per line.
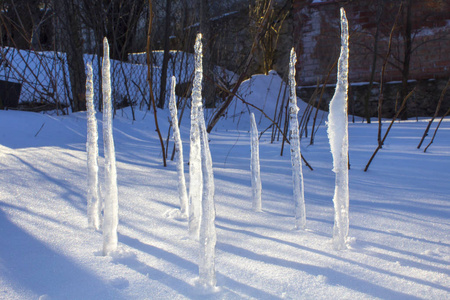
[169, 76, 189, 217]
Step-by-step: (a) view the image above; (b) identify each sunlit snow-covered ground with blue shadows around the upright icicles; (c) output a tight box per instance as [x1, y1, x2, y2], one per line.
[0, 72, 450, 299]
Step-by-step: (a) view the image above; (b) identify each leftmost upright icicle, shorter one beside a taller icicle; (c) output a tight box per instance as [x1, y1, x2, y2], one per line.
[86, 62, 101, 230]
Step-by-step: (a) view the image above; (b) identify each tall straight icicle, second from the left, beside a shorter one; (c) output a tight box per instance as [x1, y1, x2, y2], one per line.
[102, 37, 119, 255]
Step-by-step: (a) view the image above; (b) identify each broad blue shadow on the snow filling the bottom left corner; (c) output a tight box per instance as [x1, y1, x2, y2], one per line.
[0, 210, 124, 299]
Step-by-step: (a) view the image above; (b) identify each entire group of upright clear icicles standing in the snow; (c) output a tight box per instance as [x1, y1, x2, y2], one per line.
[86, 8, 349, 288]
